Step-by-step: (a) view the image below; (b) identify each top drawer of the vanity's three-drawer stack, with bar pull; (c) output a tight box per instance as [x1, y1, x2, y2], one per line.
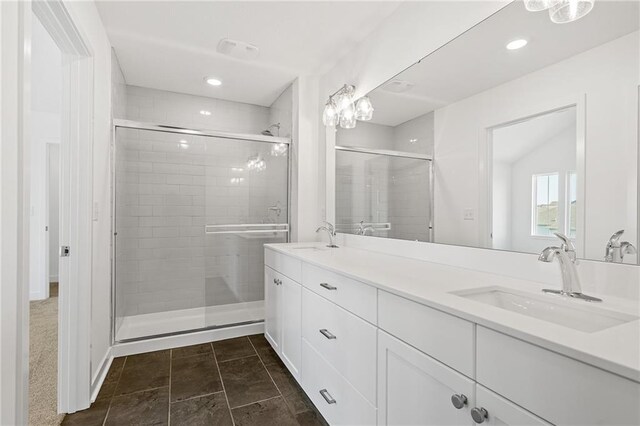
[302, 263, 377, 324]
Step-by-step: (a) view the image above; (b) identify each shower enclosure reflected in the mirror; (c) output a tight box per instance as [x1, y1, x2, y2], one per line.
[335, 146, 433, 242]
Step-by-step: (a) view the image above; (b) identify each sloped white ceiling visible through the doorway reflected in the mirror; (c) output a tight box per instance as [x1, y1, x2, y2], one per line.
[492, 107, 576, 163]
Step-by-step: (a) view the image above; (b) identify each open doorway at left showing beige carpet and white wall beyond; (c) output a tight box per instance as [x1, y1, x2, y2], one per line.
[29, 12, 64, 425]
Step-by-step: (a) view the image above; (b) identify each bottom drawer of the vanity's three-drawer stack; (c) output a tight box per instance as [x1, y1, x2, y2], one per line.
[302, 339, 376, 426]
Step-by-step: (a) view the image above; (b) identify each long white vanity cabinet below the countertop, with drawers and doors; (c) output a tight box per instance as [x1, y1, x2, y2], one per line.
[265, 248, 640, 426]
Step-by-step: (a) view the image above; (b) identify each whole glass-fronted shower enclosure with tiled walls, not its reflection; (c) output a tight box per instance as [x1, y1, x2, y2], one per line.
[112, 120, 289, 342]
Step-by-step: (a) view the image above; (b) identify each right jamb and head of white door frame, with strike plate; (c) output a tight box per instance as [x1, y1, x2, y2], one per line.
[33, 0, 93, 413]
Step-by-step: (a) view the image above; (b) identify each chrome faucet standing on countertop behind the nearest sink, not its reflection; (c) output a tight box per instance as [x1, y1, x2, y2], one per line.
[538, 232, 602, 302]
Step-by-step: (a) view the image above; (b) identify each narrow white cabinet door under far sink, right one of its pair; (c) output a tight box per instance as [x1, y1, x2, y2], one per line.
[280, 276, 302, 379]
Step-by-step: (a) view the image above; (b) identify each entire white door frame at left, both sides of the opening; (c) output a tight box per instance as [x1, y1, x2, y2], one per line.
[0, 0, 93, 424]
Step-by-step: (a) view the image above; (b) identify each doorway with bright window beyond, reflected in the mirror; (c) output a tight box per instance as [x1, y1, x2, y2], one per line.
[489, 106, 583, 253]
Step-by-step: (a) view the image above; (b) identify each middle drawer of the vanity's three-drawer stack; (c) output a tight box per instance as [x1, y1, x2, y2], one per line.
[302, 289, 376, 406]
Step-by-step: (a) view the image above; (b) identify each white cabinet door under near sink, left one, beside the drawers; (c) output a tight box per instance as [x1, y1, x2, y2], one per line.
[378, 331, 475, 426]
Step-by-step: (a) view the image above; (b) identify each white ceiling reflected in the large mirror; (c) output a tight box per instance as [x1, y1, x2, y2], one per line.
[370, 0, 640, 126]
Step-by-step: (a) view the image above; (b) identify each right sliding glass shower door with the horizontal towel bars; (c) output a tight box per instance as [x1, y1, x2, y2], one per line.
[205, 139, 289, 327]
